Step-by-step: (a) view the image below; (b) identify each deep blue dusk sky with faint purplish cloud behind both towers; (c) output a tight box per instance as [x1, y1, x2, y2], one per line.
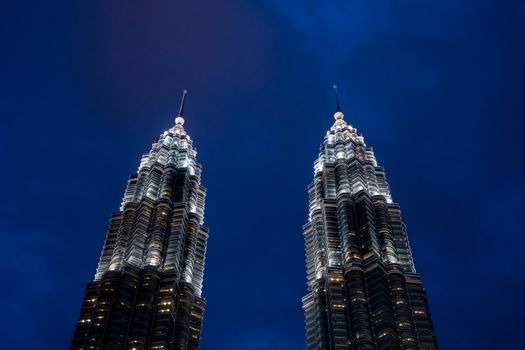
[0, 0, 525, 350]
